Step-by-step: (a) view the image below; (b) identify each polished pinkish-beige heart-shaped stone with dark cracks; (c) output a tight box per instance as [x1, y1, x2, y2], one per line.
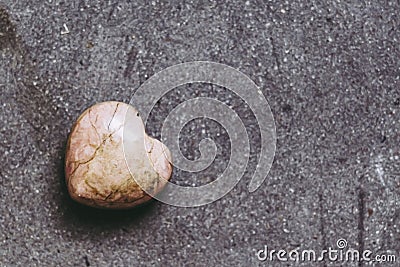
[65, 102, 172, 209]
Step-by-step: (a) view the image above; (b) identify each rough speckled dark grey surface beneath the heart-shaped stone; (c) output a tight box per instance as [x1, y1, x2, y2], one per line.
[0, 0, 400, 266]
